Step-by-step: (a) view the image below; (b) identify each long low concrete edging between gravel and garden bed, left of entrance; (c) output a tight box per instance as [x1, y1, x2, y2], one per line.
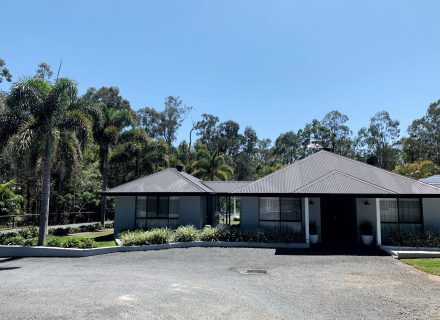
[0, 241, 310, 258]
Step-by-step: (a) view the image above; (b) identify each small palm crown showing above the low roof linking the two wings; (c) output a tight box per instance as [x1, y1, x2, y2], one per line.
[192, 143, 234, 181]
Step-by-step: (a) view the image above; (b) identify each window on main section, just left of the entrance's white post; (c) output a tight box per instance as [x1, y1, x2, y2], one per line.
[260, 197, 302, 231]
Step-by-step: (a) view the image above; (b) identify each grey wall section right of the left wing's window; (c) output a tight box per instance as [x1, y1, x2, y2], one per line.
[179, 196, 206, 228]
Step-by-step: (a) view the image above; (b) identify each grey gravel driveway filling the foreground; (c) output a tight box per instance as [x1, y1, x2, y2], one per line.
[0, 248, 440, 320]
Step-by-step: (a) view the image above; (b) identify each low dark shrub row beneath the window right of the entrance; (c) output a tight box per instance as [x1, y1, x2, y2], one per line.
[389, 232, 440, 248]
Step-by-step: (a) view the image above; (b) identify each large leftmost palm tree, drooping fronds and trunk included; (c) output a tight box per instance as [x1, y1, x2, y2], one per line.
[0, 78, 91, 245]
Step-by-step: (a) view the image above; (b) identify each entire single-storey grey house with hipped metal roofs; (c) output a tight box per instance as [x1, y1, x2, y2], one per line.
[106, 150, 440, 245]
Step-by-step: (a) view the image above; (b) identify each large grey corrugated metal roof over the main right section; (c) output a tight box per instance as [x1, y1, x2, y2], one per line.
[235, 151, 440, 195]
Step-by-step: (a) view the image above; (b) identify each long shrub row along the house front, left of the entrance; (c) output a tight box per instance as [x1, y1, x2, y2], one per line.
[119, 226, 304, 246]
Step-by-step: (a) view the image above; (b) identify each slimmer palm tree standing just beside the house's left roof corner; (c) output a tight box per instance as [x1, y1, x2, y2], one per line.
[81, 87, 136, 224]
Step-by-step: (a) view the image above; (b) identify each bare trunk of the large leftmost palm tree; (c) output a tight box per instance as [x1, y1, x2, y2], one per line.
[38, 134, 52, 246]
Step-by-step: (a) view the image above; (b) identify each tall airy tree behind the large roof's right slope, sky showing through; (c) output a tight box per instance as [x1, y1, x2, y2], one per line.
[358, 111, 400, 170]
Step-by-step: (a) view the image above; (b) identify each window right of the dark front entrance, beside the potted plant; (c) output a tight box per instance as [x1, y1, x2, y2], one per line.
[380, 198, 423, 242]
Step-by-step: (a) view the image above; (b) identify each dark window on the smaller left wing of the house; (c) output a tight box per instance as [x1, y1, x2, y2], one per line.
[136, 196, 179, 229]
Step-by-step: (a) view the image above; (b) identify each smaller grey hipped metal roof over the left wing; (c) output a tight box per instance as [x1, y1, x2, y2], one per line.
[105, 168, 212, 195]
